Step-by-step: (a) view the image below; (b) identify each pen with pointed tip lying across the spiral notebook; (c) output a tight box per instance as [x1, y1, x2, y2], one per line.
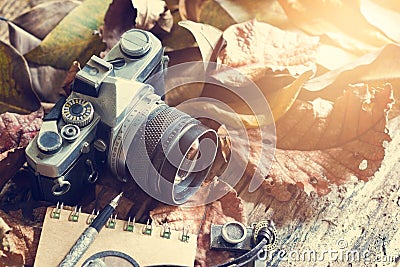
[58, 193, 122, 267]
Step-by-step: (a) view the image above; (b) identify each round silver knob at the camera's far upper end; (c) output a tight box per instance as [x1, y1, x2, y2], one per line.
[120, 29, 151, 57]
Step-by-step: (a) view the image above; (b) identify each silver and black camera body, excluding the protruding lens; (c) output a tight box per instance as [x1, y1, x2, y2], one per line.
[26, 29, 168, 205]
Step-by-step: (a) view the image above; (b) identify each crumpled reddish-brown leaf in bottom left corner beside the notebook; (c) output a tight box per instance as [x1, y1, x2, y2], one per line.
[0, 210, 40, 266]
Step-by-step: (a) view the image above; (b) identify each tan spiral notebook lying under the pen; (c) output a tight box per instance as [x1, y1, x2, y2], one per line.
[34, 208, 197, 267]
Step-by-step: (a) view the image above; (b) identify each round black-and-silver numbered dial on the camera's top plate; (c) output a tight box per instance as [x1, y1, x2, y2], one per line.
[61, 98, 94, 127]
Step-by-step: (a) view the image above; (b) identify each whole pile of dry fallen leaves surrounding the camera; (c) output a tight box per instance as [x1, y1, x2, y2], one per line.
[0, 0, 400, 266]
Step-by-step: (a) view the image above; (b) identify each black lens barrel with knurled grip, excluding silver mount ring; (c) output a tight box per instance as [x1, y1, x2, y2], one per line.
[126, 104, 217, 204]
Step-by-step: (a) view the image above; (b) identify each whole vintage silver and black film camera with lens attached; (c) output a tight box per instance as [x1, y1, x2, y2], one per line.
[26, 29, 217, 205]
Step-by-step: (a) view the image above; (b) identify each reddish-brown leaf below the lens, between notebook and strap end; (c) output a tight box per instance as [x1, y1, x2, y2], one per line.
[150, 182, 247, 266]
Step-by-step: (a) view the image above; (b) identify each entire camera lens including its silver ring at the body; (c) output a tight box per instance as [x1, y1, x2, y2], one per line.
[111, 85, 218, 205]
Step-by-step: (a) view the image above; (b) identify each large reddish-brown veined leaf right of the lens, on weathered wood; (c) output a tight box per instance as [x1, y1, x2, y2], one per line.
[193, 84, 393, 201]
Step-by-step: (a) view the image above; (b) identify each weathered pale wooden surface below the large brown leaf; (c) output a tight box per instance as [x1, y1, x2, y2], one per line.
[237, 118, 400, 266]
